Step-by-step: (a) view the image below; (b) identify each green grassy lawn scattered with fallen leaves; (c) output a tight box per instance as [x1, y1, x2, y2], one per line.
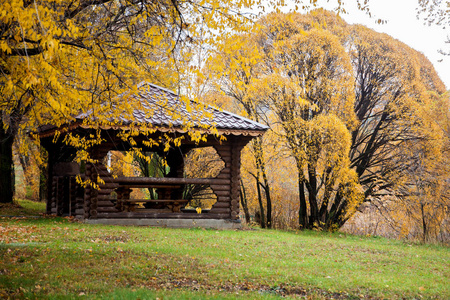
[0, 202, 450, 299]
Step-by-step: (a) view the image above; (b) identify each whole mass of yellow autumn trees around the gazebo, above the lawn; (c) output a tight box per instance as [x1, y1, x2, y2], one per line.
[0, 1, 450, 242]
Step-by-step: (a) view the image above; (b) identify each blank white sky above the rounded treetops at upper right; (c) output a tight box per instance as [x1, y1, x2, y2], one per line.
[312, 0, 450, 89]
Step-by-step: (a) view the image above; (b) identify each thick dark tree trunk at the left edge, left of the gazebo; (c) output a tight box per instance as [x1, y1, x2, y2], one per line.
[0, 124, 14, 203]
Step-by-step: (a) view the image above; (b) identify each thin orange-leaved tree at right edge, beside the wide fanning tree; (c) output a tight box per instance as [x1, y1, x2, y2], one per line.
[382, 94, 450, 242]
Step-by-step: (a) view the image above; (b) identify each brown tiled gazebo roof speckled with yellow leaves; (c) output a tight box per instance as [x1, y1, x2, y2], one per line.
[39, 81, 268, 137]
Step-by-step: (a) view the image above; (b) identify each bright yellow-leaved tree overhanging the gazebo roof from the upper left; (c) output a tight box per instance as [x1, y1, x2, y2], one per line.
[0, 0, 274, 202]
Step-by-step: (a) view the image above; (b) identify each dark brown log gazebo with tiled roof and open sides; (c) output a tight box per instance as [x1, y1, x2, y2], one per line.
[39, 82, 267, 228]
